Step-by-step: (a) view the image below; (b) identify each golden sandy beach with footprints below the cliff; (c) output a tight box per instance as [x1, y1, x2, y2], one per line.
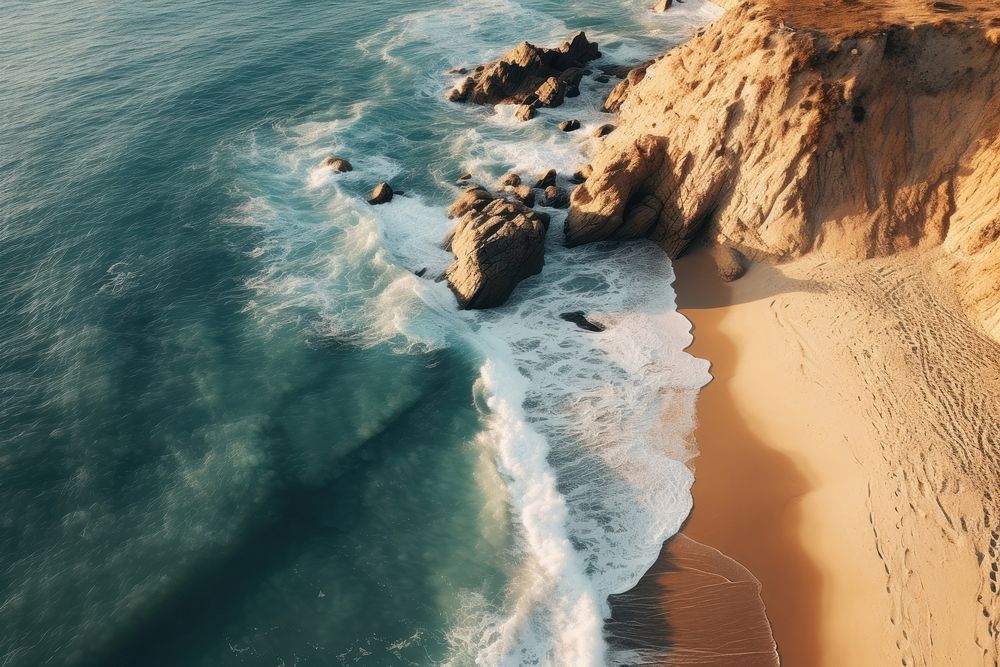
[620, 253, 1000, 667]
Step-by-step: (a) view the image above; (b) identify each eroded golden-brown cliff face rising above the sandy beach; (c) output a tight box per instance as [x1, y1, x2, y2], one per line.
[566, 0, 1000, 336]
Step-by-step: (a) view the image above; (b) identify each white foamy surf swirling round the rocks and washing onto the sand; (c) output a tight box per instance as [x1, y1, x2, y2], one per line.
[229, 0, 717, 666]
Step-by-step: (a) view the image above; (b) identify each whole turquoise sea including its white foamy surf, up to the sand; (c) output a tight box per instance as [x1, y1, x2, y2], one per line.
[0, 0, 714, 666]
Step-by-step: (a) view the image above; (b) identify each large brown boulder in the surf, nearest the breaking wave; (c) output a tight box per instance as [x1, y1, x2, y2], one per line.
[445, 186, 549, 308]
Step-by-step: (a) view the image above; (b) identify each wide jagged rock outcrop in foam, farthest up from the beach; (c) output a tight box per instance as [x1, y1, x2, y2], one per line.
[448, 32, 601, 120]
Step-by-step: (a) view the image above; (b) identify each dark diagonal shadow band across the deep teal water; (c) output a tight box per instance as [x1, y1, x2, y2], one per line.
[73, 350, 471, 667]
